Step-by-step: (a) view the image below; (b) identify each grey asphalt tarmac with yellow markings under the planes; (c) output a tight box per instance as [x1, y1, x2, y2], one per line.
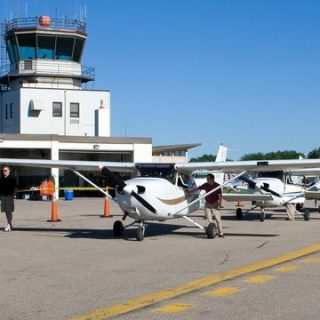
[0, 198, 320, 320]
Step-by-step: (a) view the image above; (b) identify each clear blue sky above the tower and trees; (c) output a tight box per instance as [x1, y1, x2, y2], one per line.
[0, 0, 320, 160]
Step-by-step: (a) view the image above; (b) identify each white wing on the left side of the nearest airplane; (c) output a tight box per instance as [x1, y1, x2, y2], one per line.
[0, 158, 136, 172]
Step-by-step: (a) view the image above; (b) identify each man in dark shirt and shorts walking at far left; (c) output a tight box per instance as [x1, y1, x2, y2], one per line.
[0, 166, 17, 232]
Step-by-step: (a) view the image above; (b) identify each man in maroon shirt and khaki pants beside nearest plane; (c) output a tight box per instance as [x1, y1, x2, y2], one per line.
[198, 173, 224, 238]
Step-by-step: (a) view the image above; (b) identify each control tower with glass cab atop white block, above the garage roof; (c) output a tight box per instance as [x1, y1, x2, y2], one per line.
[0, 16, 110, 136]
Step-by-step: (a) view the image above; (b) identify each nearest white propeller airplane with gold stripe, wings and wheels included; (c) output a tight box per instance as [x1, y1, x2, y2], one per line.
[0, 159, 320, 241]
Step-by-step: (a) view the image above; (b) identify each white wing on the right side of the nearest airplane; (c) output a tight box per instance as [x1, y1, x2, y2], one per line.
[175, 159, 320, 173]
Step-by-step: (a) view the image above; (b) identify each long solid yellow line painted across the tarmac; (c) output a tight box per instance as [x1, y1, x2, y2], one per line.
[70, 244, 320, 320]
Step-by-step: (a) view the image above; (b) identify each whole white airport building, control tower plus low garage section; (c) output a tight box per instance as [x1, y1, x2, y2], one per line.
[0, 16, 152, 195]
